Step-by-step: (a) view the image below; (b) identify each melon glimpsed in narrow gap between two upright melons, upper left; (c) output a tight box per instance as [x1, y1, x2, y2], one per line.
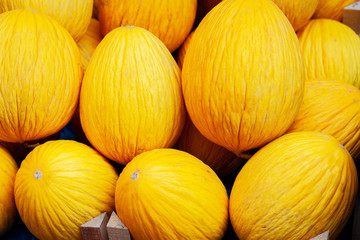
[77, 18, 102, 71]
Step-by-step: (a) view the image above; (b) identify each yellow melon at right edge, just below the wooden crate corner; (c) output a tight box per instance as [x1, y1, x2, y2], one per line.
[298, 19, 360, 88]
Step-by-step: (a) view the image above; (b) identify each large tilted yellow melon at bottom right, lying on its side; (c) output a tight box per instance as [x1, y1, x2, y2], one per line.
[229, 132, 358, 240]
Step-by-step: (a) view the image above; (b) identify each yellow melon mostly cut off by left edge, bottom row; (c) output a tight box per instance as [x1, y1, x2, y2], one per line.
[0, 146, 18, 236]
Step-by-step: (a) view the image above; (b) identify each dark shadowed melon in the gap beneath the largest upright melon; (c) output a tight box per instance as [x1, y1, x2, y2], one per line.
[176, 117, 246, 177]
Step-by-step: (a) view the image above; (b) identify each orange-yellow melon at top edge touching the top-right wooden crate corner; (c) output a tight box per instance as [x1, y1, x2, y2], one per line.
[313, 0, 357, 21]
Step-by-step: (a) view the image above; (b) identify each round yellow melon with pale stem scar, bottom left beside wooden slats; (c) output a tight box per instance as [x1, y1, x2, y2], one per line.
[14, 140, 118, 239]
